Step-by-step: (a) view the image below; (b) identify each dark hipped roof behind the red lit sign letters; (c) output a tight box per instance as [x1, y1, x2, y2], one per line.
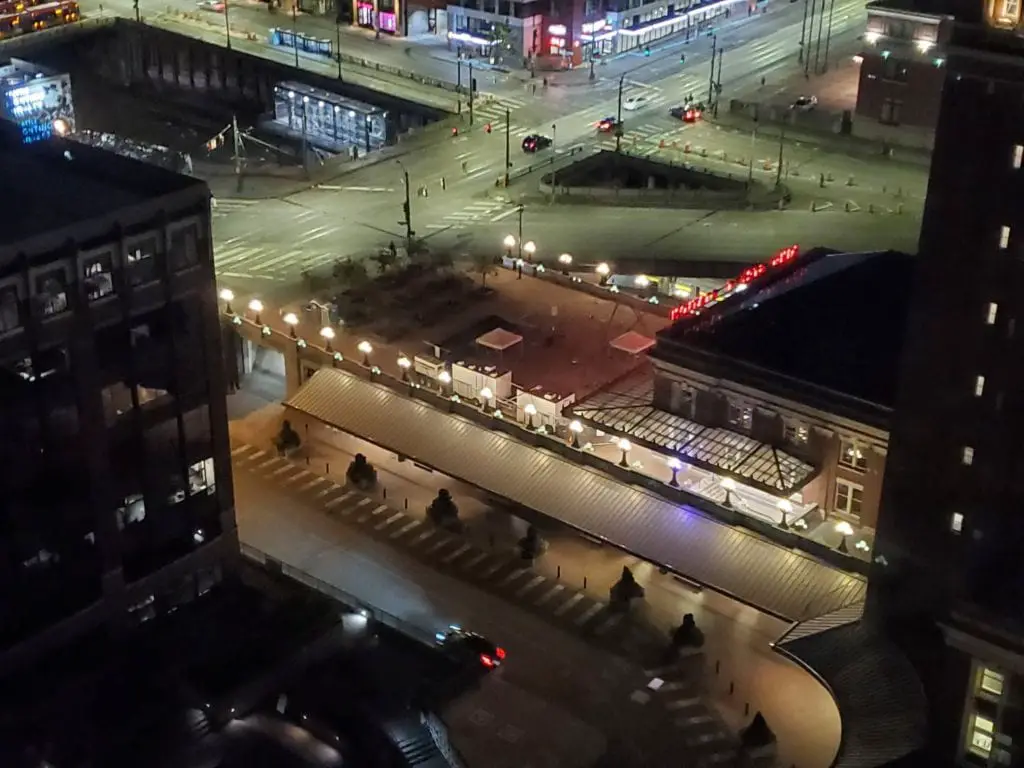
[653, 251, 914, 417]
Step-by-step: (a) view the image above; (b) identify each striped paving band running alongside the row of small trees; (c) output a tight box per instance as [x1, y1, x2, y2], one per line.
[231, 444, 736, 765]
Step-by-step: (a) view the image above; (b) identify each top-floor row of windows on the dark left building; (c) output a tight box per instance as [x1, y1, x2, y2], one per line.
[0, 219, 201, 335]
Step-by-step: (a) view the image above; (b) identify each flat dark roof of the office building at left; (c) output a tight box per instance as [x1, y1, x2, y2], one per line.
[0, 121, 206, 247]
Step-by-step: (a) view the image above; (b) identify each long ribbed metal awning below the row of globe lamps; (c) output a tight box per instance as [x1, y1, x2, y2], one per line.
[286, 369, 865, 620]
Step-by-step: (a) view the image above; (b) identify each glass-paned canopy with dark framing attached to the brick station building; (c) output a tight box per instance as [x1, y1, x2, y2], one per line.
[572, 374, 818, 496]
